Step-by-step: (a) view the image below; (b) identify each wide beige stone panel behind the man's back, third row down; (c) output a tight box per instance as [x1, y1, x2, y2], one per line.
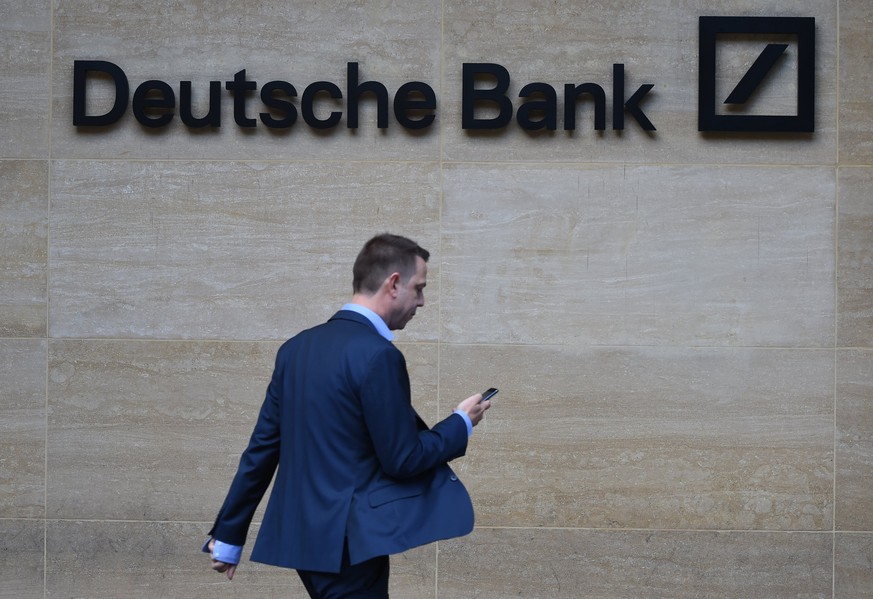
[47, 341, 437, 524]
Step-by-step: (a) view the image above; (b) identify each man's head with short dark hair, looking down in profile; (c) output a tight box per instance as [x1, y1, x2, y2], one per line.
[352, 233, 430, 330]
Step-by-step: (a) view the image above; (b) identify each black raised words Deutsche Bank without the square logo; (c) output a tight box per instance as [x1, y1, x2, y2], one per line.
[73, 60, 655, 131]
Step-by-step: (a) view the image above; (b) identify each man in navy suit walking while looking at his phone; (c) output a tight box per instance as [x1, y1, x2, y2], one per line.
[204, 234, 491, 599]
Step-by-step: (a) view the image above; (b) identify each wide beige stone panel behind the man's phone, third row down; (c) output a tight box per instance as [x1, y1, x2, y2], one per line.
[440, 345, 834, 530]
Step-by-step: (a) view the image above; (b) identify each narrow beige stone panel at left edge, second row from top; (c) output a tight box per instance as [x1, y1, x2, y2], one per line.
[0, 160, 49, 337]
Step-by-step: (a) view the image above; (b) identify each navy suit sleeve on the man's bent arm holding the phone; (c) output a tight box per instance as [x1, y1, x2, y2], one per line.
[361, 346, 468, 479]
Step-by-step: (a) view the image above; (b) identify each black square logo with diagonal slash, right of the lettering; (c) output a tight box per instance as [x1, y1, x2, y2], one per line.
[697, 17, 815, 132]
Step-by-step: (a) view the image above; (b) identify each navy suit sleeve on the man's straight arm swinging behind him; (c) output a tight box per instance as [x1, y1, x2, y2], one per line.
[208, 350, 282, 545]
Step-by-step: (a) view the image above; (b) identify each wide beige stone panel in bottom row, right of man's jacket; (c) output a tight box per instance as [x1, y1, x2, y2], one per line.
[438, 528, 833, 599]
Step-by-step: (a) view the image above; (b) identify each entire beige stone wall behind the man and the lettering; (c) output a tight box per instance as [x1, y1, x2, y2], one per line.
[0, 0, 873, 599]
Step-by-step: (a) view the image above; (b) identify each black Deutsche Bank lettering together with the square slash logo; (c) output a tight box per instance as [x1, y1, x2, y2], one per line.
[73, 17, 815, 137]
